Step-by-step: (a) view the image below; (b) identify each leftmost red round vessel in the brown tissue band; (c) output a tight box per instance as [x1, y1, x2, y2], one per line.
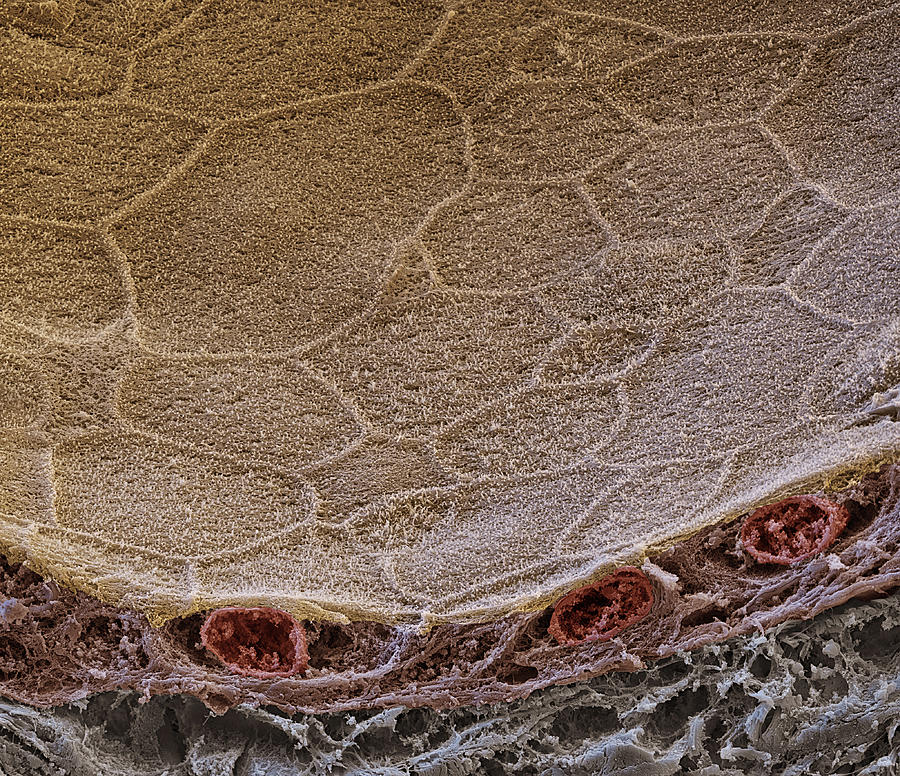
[200, 606, 309, 679]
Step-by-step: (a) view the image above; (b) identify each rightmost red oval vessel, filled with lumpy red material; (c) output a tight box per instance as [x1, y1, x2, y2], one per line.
[741, 496, 850, 566]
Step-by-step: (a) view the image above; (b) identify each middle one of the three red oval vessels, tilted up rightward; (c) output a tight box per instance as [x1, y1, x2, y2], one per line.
[547, 566, 653, 644]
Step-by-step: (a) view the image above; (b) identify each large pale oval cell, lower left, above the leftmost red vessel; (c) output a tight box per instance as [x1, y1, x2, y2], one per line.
[53, 434, 316, 557]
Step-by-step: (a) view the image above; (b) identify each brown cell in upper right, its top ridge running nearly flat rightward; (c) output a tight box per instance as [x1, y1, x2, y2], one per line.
[607, 35, 807, 126]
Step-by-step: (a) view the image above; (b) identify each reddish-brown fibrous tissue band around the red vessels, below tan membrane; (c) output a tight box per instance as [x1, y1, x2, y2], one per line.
[0, 465, 900, 713]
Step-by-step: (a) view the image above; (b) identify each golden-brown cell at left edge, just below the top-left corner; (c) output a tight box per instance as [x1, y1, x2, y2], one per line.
[0, 28, 128, 100]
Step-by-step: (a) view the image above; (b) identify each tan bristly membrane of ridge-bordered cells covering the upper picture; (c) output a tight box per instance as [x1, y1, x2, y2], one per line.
[0, 0, 900, 624]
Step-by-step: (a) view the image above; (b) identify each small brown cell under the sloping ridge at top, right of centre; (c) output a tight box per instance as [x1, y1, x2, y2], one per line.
[514, 15, 665, 81]
